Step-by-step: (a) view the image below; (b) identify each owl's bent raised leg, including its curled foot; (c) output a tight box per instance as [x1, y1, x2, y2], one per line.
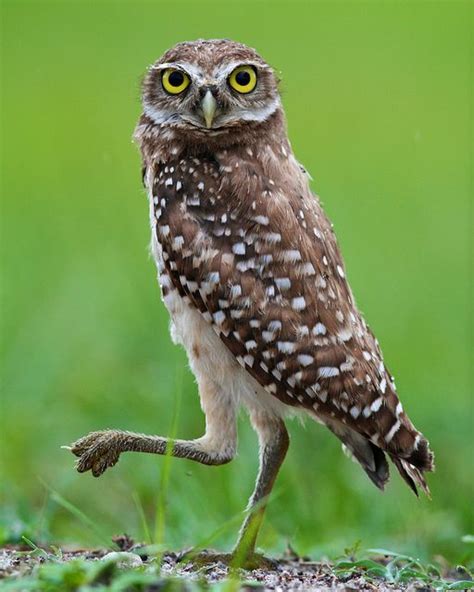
[65, 381, 237, 477]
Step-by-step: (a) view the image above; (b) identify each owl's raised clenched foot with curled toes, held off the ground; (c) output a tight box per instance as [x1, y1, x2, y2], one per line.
[67, 430, 121, 477]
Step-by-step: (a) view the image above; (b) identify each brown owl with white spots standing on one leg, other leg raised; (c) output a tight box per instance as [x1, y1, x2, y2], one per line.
[71, 39, 434, 561]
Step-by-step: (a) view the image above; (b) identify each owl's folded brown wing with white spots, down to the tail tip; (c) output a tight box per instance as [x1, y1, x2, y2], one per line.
[155, 163, 434, 490]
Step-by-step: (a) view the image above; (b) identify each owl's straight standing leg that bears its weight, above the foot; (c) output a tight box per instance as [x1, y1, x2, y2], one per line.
[233, 410, 290, 564]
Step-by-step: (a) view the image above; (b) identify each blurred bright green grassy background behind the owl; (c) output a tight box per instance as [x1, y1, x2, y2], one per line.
[1, 0, 474, 561]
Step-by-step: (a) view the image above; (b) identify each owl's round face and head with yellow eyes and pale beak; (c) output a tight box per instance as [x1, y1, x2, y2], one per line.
[143, 39, 280, 136]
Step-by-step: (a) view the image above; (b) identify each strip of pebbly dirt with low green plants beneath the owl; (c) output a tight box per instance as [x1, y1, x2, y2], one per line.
[0, 540, 468, 592]
